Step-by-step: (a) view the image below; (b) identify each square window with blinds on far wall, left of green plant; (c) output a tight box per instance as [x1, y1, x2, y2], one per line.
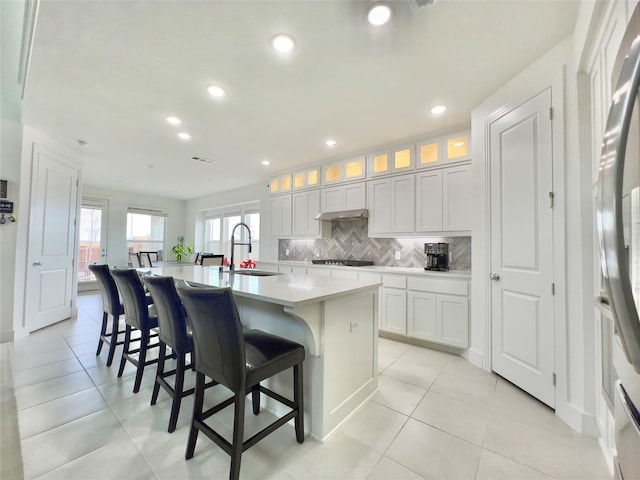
[127, 208, 167, 252]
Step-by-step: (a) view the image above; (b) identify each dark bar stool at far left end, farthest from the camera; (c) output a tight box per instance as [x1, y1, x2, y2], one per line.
[89, 264, 125, 367]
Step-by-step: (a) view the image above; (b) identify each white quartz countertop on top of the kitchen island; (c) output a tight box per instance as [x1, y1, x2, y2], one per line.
[138, 264, 381, 307]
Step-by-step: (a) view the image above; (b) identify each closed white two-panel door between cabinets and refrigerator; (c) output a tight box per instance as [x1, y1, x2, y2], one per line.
[489, 89, 555, 407]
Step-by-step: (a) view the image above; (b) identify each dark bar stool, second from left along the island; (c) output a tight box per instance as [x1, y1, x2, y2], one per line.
[111, 269, 159, 393]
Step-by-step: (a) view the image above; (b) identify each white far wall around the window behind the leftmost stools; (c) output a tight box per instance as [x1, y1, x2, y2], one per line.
[82, 186, 191, 267]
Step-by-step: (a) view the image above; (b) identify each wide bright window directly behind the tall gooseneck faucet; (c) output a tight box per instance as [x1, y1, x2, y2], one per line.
[203, 203, 260, 264]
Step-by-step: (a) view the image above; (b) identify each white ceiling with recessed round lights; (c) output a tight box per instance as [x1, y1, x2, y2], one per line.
[23, 0, 579, 199]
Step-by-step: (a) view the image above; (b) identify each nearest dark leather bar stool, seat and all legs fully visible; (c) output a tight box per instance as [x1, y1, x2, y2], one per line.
[177, 281, 305, 480]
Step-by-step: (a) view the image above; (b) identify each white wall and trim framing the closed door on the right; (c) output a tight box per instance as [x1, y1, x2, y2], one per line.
[470, 38, 594, 433]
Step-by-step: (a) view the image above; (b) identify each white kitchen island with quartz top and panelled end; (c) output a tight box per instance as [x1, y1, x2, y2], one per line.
[140, 265, 380, 440]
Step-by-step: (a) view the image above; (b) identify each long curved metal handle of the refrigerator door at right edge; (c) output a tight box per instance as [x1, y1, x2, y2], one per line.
[596, 22, 640, 374]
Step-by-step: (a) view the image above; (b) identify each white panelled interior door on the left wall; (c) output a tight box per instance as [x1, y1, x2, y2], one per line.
[25, 145, 78, 332]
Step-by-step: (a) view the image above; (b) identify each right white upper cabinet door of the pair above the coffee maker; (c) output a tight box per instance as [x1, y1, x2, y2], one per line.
[442, 165, 472, 231]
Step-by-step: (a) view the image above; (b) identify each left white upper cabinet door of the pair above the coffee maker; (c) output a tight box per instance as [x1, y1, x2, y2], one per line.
[416, 170, 442, 232]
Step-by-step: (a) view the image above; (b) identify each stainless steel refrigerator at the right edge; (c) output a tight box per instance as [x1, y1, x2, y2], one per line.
[596, 5, 640, 480]
